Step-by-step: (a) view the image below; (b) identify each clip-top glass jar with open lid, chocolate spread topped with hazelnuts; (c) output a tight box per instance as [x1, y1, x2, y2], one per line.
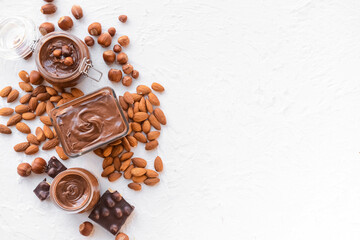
[0, 17, 102, 87]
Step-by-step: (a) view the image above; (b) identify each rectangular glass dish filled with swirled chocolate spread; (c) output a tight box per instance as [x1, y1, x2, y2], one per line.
[50, 87, 129, 157]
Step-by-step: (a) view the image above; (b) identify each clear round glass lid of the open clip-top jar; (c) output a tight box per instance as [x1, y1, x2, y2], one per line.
[0, 17, 39, 60]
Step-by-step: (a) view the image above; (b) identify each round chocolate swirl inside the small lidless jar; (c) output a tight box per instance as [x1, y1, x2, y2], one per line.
[56, 174, 90, 208]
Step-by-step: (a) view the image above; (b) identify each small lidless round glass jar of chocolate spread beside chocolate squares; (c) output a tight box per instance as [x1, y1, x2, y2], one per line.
[50, 168, 100, 213]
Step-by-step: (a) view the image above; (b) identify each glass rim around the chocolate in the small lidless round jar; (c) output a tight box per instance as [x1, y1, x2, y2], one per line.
[50, 168, 99, 213]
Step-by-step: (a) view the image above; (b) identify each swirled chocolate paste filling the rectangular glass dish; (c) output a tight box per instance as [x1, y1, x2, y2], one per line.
[55, 91, 125, 153]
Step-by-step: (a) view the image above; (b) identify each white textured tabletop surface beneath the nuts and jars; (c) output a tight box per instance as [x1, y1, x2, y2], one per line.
[0, 0, 360, 240]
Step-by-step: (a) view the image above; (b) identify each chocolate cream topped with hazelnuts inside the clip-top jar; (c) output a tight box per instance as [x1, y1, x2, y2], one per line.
[39, 36, 80, 77]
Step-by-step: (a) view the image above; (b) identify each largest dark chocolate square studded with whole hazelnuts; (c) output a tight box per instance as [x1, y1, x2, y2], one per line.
[89, 190, 134, 235]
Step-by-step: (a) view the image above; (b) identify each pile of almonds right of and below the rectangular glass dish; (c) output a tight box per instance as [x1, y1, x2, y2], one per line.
[94, 83, 166, 191]
